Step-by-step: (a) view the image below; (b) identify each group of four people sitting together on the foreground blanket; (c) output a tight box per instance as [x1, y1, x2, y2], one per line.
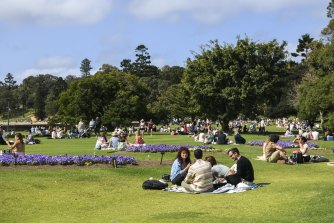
[170, 147, 254, 193]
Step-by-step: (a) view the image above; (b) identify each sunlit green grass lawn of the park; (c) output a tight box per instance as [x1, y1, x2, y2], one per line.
[0, 129, 334, 222]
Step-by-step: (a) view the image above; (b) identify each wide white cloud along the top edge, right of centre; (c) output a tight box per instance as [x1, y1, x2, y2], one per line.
[129, 0, 319, 23]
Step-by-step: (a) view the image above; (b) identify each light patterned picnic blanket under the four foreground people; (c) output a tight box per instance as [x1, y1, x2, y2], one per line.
[164, 183, 265, 194]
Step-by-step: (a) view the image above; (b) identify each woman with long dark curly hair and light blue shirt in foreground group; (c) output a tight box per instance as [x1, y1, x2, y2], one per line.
[170, 147, 191, 186]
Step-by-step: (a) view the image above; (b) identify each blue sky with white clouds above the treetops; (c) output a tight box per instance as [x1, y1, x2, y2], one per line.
[0, 0, 329, 83]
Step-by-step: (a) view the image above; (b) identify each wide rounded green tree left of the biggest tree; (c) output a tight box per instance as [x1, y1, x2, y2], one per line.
[57, 71, 148, 127]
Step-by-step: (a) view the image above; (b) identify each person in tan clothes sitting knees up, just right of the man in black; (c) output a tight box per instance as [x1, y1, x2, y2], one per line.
[263, 134, 288, 163]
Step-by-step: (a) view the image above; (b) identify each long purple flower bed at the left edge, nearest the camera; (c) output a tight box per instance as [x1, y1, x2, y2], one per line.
[0, 154, 137, 166]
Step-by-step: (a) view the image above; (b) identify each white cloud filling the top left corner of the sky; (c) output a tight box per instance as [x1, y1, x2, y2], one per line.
[0, 0, 112, 25]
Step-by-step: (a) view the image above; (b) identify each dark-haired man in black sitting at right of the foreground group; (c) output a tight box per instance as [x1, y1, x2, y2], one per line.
[225, 148, 254, 185]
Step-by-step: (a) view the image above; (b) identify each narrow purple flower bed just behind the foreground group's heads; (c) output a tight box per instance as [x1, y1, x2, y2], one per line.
[126, 144, 213, 153]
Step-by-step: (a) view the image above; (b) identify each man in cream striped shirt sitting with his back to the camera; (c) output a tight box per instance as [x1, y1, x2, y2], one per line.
[181, 149, 213, 193]
